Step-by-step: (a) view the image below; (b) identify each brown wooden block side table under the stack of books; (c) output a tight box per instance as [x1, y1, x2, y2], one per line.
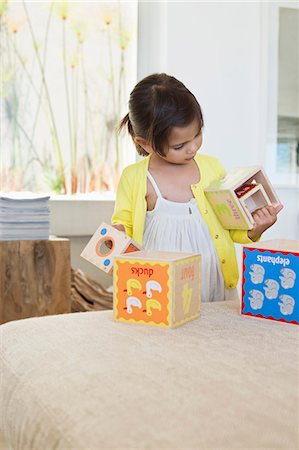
[0, 238, 71, 324]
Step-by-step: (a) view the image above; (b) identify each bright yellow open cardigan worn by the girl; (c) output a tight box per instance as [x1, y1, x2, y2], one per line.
[112, 153, 252, 288]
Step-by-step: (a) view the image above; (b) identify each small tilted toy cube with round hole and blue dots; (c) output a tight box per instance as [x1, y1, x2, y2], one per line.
[80, 222, 140, 275]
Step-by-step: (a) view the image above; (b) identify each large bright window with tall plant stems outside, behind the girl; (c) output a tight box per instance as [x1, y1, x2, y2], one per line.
[0, 1, 137, 194]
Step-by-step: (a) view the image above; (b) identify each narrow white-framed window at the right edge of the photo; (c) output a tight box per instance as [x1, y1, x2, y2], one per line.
[265, 2, 299, 187]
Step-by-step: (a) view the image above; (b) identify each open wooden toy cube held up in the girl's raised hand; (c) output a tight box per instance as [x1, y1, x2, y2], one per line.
[205, 166, 282, 230]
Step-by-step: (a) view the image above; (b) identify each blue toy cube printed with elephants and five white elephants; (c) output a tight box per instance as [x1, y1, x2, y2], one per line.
[241, 239, 299, 325]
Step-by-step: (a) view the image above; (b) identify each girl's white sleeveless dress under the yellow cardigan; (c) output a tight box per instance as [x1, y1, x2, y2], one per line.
[143, 172, 227, 302]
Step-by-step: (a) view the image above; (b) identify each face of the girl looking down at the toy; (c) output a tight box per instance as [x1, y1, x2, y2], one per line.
[161, 118, 202, 164]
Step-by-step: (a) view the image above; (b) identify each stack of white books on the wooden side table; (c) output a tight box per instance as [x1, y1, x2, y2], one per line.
[0, 192, 50, 241]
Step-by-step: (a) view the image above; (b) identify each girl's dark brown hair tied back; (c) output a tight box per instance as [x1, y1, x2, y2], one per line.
[119, 73, 204, 156]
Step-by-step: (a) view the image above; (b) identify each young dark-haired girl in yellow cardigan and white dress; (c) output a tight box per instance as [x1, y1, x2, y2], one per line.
[112, 73, 276, 302]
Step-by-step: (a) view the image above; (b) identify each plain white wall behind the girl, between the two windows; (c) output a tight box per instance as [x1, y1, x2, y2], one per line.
[138, 2, 261, 168]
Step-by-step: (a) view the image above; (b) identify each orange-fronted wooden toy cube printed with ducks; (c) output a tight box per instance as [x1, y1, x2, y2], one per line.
[113, 251, 200, 328]
